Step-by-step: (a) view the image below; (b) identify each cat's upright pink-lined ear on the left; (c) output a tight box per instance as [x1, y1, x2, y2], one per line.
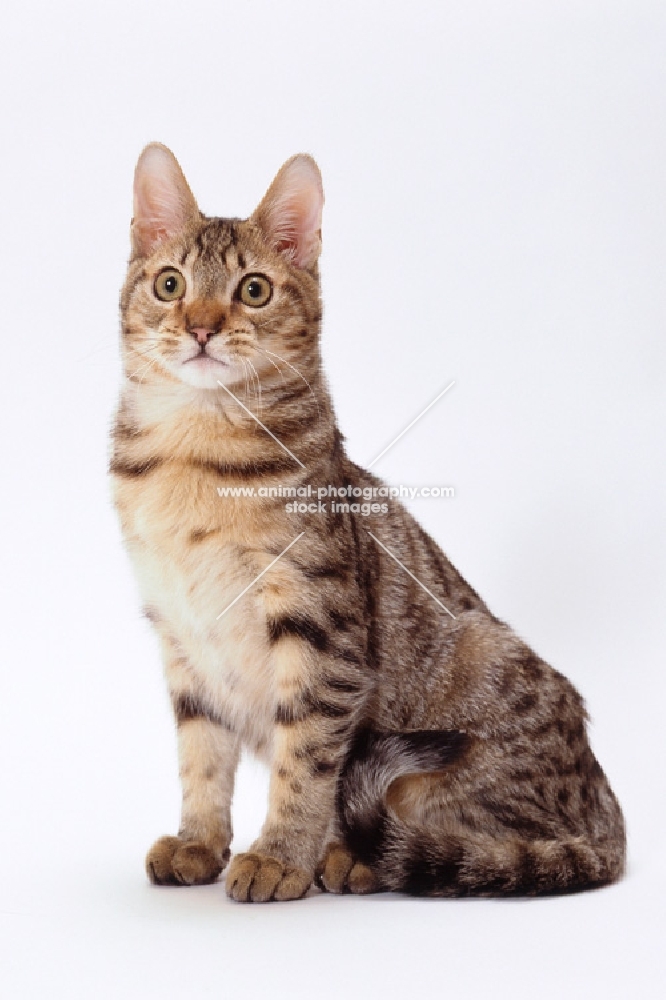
[132, 142, 201, 255]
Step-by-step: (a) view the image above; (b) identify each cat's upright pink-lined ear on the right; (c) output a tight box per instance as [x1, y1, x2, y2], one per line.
[252, 153, 324, 268]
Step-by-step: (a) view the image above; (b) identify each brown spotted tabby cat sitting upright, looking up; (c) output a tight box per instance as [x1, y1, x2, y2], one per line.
[111, 144, 625, 901]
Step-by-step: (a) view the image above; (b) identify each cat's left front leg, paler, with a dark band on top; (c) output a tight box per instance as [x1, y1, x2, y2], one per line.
[146, 692, 240, 885]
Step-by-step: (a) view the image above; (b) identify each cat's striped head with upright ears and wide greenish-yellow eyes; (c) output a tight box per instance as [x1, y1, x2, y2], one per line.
[121, 143, 324, 390]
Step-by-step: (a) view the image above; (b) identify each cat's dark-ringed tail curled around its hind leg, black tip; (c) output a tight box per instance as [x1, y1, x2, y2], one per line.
[338, 730, 624, 896]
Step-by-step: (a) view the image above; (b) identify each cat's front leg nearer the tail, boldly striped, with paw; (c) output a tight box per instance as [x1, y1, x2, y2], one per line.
[226, 629, 366, 902]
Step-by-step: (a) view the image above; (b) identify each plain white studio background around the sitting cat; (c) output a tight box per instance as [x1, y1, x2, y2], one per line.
[0, 0, 666, 1000]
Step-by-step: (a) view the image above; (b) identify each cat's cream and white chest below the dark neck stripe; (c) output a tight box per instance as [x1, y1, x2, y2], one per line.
[115, 454, 302, 749]
